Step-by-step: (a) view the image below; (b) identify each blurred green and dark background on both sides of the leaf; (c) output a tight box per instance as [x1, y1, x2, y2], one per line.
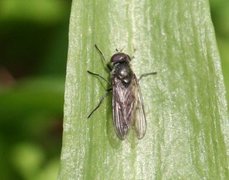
[0, 0, 229, 180]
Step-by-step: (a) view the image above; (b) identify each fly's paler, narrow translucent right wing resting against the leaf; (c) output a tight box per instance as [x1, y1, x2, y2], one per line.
[133, 76, 147, 139]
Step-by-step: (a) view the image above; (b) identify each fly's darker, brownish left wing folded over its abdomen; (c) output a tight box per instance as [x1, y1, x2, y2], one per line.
[112, 77, 136, 140]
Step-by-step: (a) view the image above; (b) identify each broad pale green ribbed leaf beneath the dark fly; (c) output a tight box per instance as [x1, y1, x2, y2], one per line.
[59, 0, 229, 180]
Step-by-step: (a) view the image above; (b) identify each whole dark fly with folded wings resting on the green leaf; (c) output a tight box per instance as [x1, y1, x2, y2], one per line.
[87, 45, 156, 140]
